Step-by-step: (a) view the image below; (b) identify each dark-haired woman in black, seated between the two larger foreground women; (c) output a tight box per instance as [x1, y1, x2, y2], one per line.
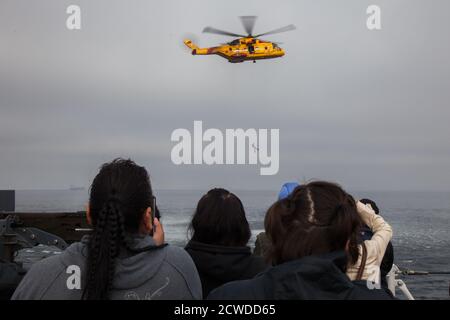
[186, 189, 266, 297]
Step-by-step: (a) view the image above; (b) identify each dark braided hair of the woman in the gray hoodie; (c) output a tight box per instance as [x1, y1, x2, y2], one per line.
[82, 159, 153, 300]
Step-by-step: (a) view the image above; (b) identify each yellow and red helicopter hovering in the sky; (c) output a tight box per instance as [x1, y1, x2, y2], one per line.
[184, 16, 295, 63]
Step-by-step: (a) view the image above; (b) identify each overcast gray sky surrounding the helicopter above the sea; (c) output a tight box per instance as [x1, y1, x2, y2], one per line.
[0, 0, 450, 190]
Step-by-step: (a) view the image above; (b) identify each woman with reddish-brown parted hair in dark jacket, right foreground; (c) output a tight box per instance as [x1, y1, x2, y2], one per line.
[208, 181, 392, 299]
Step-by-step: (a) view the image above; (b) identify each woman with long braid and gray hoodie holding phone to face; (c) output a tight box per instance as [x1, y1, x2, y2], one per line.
[12, 159, 202, 300]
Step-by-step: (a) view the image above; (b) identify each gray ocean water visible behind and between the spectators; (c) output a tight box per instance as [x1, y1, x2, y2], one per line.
[16, 190, 450, 299]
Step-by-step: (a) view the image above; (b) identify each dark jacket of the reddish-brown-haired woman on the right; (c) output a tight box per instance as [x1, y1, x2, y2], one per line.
[208, 252, 393, 300]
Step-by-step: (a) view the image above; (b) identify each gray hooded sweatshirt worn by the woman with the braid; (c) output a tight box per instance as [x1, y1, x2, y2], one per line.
[12, 235, 202, 300]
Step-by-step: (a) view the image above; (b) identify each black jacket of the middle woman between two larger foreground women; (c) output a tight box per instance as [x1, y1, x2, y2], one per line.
[185, 240, 267, 297]
